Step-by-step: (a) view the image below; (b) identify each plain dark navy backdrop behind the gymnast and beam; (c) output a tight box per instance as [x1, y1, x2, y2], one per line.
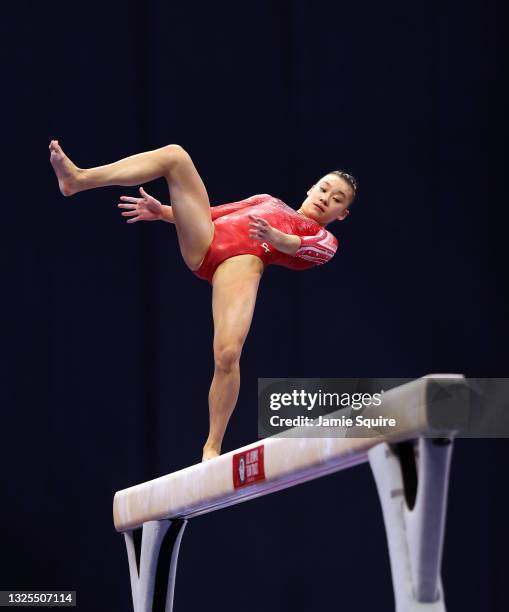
[0, 0, 509, 612]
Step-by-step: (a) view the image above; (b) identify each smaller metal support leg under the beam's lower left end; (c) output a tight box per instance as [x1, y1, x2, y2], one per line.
[124, 520, 187, 612]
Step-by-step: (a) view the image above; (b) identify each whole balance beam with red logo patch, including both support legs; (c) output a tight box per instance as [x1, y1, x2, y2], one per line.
[113, 375, 469, 612]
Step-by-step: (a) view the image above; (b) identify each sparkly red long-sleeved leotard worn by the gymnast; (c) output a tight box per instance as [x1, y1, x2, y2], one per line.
[195, 194, 338, 282]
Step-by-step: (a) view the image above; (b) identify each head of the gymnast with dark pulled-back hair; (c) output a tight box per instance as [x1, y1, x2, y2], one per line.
[299, 174, 353, 225]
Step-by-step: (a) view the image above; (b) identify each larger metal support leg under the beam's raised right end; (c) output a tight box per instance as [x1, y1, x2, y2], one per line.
[369, 438, 452, 612]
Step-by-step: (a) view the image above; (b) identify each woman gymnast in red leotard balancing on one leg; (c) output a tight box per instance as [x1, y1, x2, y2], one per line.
[49, 140, 357, 461]
